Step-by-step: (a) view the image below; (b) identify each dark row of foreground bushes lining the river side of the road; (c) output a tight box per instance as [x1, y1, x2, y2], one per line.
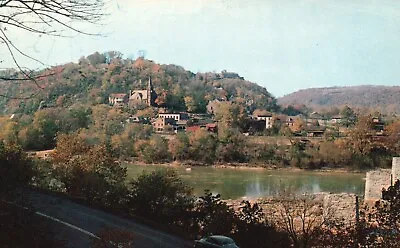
[0, 136, 400, 248]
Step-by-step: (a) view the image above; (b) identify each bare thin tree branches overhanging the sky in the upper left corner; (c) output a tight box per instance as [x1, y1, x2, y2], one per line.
[0, 0, 105, 97]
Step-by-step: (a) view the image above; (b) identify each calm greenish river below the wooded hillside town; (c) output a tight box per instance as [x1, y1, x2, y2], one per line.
[127, 165, 365, 199]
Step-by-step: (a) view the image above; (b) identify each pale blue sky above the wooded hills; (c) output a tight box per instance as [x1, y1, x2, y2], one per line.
[0, 0, 400, 97]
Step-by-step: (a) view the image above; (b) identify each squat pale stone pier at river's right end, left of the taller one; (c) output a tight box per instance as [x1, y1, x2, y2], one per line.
[364, 169, 392, 201]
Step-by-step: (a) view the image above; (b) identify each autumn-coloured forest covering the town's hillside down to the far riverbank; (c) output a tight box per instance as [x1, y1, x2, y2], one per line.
[0, 51, 400, 169]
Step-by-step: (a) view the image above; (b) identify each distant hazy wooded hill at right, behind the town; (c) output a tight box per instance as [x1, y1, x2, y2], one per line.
[278, 86, 400, 114]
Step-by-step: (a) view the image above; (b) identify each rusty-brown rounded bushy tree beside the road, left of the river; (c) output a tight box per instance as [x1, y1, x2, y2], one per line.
[52, 134, 126, 206]
